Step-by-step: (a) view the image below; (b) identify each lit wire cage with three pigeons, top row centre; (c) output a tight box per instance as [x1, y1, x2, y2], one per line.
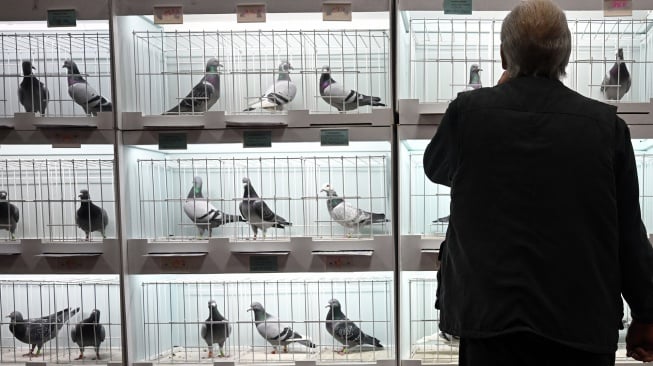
[126, 29, 390, 115]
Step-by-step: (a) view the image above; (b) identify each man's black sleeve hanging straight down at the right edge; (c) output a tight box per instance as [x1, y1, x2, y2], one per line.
[615, 118, 653, 323]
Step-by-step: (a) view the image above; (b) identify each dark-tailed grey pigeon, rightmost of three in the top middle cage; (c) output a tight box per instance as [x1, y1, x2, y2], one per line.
[320, 65, 385, 112]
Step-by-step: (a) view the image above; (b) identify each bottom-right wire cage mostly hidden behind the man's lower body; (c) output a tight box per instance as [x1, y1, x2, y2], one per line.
[408, 278, 632, 364]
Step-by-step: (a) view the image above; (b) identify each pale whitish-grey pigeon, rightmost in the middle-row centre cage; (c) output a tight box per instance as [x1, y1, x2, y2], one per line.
[320, 183, 389, 236]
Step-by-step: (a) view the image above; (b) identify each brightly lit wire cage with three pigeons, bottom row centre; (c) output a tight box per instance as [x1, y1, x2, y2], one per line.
[141, 273, 394, 363]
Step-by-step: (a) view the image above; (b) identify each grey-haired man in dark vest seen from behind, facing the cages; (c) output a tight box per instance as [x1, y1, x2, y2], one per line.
[424, 0, 653, 366]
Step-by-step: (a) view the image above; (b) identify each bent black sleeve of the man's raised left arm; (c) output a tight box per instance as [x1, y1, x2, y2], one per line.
[423, 98, 459, 187]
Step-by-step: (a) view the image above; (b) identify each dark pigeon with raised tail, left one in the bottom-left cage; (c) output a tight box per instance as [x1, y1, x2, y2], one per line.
[7, 308, 79, 357]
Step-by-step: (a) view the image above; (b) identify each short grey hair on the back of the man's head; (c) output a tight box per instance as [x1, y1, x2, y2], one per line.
[501, 0, 571, 79]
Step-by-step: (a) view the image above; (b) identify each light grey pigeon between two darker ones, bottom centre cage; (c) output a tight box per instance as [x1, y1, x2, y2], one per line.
[247, 302, 316, 354]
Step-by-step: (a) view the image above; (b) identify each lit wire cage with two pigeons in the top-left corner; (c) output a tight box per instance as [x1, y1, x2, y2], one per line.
[0, 30, 111, 117]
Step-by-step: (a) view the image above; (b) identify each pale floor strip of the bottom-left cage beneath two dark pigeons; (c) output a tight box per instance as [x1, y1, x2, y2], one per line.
[0, 347, 122, 366]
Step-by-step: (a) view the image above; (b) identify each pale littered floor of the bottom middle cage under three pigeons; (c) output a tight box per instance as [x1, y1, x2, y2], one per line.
[150, 346, 394, 364]
